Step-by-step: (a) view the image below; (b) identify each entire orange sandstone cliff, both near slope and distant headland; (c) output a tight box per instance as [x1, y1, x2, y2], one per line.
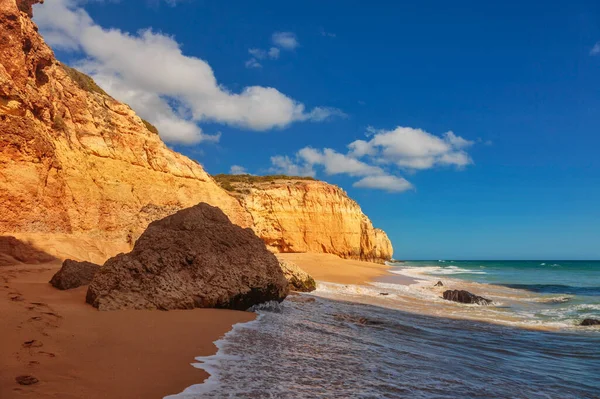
[0, 0, 392, 263]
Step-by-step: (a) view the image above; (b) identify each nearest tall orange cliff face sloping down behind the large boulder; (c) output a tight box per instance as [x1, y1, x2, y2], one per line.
[0, 0, 252, 255]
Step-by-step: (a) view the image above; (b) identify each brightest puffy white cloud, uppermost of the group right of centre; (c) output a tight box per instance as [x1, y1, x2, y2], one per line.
[348, 127, 474, 169]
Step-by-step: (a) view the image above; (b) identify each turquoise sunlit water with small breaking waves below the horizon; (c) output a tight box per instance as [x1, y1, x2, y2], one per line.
[395, 260, 600, 325]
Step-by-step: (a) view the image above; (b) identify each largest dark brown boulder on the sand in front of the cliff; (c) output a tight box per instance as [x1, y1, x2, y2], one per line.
[86, 203, 288, 310]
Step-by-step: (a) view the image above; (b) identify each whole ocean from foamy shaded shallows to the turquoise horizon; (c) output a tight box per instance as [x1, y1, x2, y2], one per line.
[170, 261, 600, 399]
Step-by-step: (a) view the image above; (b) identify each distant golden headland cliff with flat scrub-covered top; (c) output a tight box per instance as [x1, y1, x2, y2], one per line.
[215, 175, 393, 262]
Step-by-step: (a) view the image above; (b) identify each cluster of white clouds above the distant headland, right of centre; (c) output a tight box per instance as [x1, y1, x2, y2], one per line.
[271, 127, 474, 193]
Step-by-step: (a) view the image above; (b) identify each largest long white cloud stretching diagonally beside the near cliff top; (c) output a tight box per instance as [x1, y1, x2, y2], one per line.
[35, 0, 337, 144]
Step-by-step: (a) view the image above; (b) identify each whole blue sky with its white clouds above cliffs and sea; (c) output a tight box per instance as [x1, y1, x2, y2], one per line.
[35, 0, 600, 259]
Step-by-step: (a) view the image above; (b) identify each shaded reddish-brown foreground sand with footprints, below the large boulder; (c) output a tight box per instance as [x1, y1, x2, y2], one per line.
[0, 262, 255, 399]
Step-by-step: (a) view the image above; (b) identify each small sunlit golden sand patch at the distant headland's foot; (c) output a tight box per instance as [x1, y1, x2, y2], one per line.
[277, 253, 389, 285]
